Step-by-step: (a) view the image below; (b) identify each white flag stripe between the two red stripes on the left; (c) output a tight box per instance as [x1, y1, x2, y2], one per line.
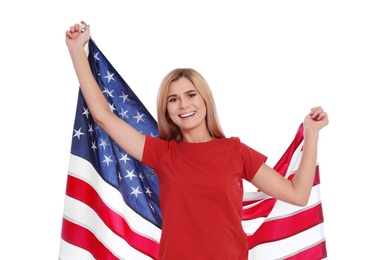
[64, 196, 151, 260]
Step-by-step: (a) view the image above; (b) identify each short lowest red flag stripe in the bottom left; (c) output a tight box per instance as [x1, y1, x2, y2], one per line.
[62, 218, 119, 260]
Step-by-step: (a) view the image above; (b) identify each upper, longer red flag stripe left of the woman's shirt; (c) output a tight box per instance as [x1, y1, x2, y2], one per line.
[66, 175, 159, 259]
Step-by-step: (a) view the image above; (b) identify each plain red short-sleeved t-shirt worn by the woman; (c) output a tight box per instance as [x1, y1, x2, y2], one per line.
[142, 136, 267, 260]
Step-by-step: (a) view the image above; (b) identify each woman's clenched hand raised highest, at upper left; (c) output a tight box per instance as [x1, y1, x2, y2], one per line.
[66, 21, 90, 49]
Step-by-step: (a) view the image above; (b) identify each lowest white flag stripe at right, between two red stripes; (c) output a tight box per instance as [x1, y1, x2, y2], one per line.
[249, 223, 325, 260]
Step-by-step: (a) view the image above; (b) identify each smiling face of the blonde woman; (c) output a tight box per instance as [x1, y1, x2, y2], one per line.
[167, 77, 207, 133]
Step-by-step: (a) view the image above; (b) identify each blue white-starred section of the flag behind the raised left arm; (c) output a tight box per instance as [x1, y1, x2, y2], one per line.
[72, 45, 161, 225]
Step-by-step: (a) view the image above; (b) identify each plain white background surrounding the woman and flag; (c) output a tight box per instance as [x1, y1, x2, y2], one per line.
[0, 0, 378, 260]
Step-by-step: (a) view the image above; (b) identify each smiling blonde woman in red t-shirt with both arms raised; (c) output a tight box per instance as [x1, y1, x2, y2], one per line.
[66, 22, 328, 260]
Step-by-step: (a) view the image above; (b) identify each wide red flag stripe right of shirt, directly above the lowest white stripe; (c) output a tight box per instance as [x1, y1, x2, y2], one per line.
[248, 204, 324, 249]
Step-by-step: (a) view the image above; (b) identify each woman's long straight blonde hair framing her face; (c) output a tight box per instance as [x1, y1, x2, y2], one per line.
[157, 68, 225, 142]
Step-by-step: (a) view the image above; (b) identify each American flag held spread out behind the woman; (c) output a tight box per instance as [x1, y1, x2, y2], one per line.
[59, 39, 327, 260]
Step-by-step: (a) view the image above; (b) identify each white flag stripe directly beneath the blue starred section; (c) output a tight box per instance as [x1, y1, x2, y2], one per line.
[69, 155, 161, 243]
